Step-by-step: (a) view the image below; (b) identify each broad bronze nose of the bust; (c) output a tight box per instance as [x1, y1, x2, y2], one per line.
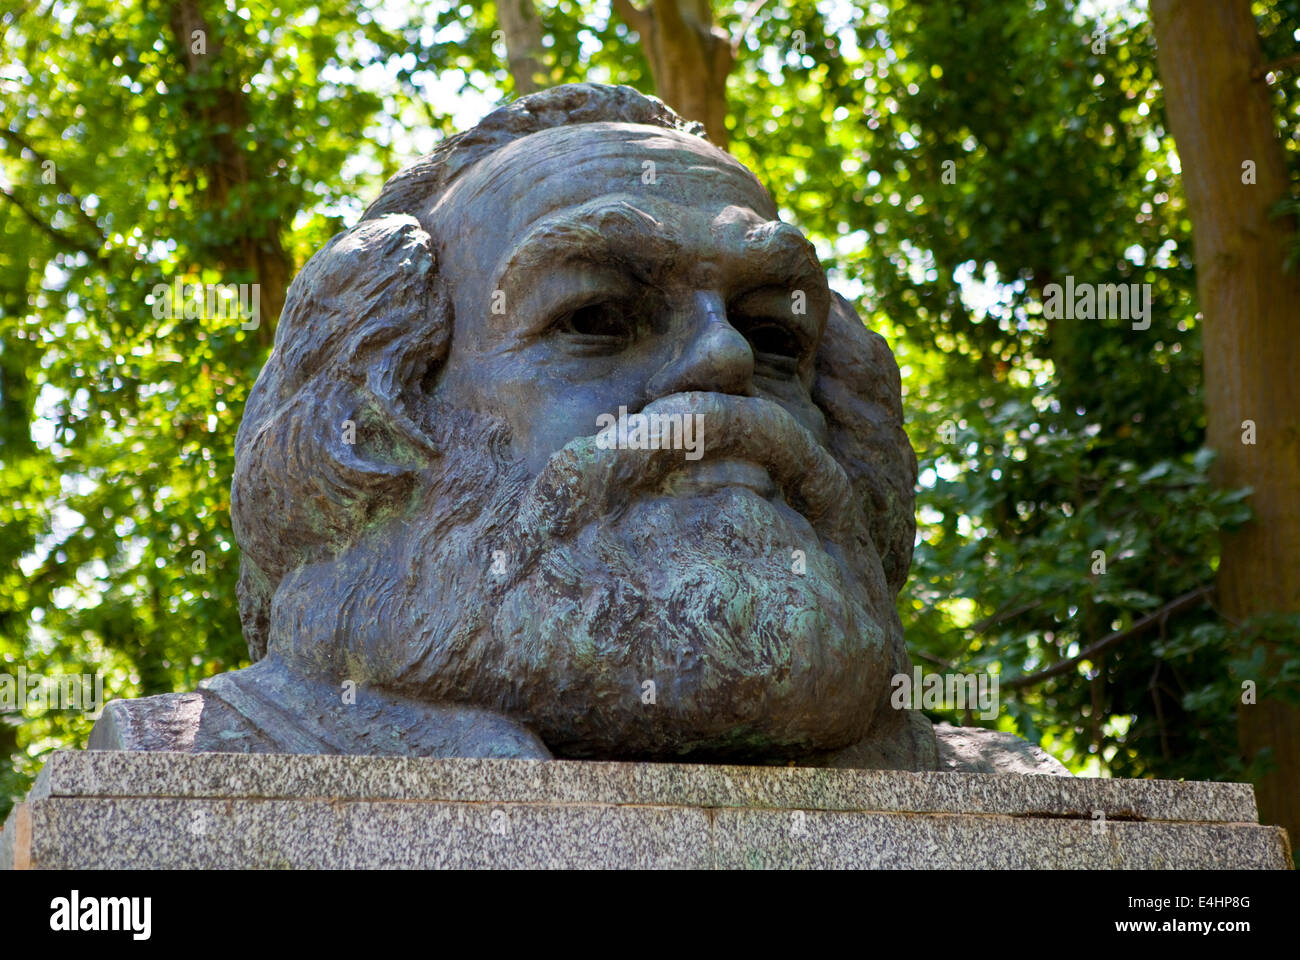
[649, 290, 754, 398]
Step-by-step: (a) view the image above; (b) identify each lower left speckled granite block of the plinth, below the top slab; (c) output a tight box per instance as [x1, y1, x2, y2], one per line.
[20, 797, 712, 870]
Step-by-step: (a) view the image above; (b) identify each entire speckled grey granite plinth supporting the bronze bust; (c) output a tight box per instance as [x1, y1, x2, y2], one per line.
[0, 751, 1291, 869]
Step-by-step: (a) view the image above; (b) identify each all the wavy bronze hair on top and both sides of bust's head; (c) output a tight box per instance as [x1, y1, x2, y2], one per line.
[230, 83, 917, 660]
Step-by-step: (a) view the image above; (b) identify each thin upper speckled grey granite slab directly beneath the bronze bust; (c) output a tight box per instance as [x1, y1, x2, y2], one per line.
[31, 751, 1257, 823]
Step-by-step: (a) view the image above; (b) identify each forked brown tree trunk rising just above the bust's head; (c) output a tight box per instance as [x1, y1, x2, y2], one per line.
[614, 0, 732, 150]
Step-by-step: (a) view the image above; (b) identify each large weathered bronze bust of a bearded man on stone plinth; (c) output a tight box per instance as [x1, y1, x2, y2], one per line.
[90, 83, 1063, 773]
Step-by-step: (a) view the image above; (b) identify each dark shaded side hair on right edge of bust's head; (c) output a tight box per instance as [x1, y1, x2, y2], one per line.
[813, 290, 917, 593]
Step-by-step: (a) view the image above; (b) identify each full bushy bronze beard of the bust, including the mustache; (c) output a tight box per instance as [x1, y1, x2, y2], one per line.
[270, 393, 902, 761]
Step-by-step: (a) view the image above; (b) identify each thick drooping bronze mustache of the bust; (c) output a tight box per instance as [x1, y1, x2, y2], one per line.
[516, 392, 854, 541]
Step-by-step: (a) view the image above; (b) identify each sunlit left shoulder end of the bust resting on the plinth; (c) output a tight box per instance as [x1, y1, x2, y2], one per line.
[86, 688, 279, 753]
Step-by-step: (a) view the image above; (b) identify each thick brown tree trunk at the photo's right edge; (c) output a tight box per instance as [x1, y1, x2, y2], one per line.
[1151, 0, 1300, 843]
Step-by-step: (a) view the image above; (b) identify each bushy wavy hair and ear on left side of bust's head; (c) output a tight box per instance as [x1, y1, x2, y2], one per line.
[230, 215, 451, 650]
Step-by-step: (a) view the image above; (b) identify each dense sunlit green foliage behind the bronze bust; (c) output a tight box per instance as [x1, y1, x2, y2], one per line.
[0, 0, 1300, 812]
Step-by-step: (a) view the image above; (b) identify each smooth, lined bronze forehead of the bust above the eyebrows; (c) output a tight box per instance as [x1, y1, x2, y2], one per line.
[436, 124, 776, 234]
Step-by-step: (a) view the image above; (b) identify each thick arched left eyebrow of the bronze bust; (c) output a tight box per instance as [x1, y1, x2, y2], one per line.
[497, 198, 677, 284]
